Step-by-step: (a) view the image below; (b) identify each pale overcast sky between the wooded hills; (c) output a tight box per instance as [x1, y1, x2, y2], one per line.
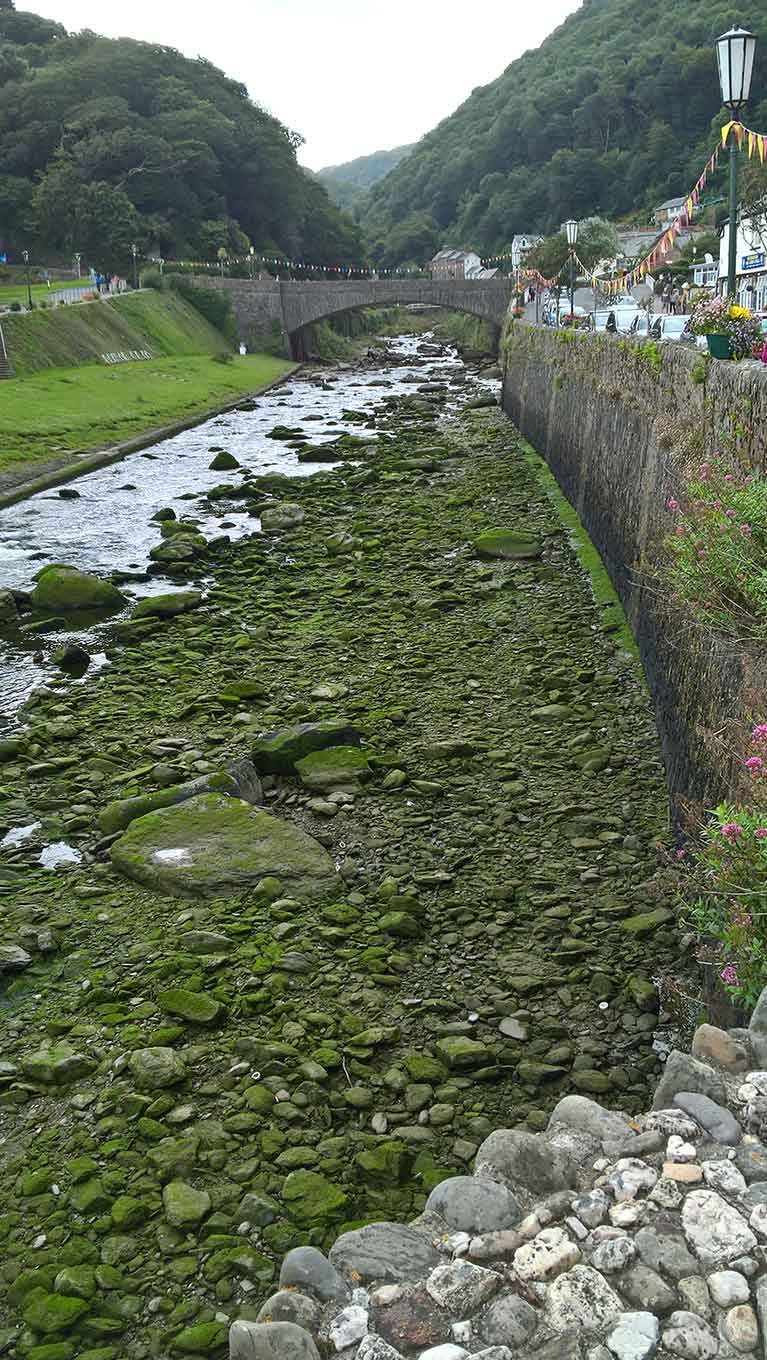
[23, 0, 581, 170]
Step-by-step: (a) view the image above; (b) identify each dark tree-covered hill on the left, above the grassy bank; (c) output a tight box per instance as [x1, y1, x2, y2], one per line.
[0, 0, 362, 267]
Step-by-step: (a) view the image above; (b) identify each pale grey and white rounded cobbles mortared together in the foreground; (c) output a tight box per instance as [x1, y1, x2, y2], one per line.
[230, 993, 767, 1360]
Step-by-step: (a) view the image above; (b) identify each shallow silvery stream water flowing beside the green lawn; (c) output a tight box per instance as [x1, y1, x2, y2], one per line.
[0, 333, 499, 730]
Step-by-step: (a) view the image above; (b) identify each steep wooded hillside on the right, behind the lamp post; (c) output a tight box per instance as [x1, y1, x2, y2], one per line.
[363, 0, 767, 253]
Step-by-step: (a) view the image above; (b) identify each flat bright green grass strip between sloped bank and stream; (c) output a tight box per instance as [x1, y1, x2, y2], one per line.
[0, 355, 292, 477]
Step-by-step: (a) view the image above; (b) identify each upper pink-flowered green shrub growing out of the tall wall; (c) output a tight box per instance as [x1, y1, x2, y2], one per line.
[665, 454, 767, 642]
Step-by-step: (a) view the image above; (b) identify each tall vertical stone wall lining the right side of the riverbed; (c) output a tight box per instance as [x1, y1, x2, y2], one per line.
[503, 324, 767, 813]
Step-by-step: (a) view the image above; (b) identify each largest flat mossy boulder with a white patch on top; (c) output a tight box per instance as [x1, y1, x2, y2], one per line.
[110, 793, 336, 898]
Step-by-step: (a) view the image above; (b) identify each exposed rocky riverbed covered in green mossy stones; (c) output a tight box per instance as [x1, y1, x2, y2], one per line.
[0, 331, 677, 1360]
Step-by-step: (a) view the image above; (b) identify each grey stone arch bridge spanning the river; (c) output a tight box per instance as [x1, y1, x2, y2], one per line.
[193, 275, 514, 356]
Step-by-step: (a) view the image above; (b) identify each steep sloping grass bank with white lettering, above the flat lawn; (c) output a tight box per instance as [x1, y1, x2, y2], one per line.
[3, 290, 230, 378]
